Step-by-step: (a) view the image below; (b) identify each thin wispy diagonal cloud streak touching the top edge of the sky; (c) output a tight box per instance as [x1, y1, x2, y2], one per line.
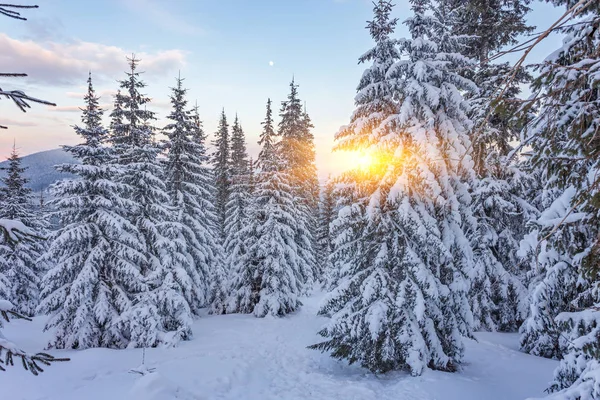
[123, 0, 203, 36]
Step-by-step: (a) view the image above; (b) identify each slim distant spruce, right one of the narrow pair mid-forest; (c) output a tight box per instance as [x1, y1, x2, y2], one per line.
[224, 115, 250, 296]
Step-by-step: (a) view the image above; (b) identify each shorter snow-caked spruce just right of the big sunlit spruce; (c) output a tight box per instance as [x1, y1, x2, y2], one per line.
[470, 166, 539, 332]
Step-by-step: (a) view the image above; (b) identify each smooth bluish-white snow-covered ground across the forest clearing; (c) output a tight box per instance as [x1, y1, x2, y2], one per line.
[0, 290, 556, 400]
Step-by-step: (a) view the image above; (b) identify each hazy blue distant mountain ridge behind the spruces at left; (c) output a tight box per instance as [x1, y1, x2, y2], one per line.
[0, 149, 76, 192]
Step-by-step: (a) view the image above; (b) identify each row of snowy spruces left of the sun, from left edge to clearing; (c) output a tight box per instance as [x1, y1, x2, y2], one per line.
[0, 58, 321, 349]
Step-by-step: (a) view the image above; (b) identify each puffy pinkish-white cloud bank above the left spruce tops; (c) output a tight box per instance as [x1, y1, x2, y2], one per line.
[0, 33, 185, 85]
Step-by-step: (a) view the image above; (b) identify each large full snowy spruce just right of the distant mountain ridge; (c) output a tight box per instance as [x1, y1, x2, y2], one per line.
[39, 75, 144, 349]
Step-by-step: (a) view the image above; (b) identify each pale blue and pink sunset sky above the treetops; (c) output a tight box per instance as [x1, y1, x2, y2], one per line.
[0, 0, 564, 178]
